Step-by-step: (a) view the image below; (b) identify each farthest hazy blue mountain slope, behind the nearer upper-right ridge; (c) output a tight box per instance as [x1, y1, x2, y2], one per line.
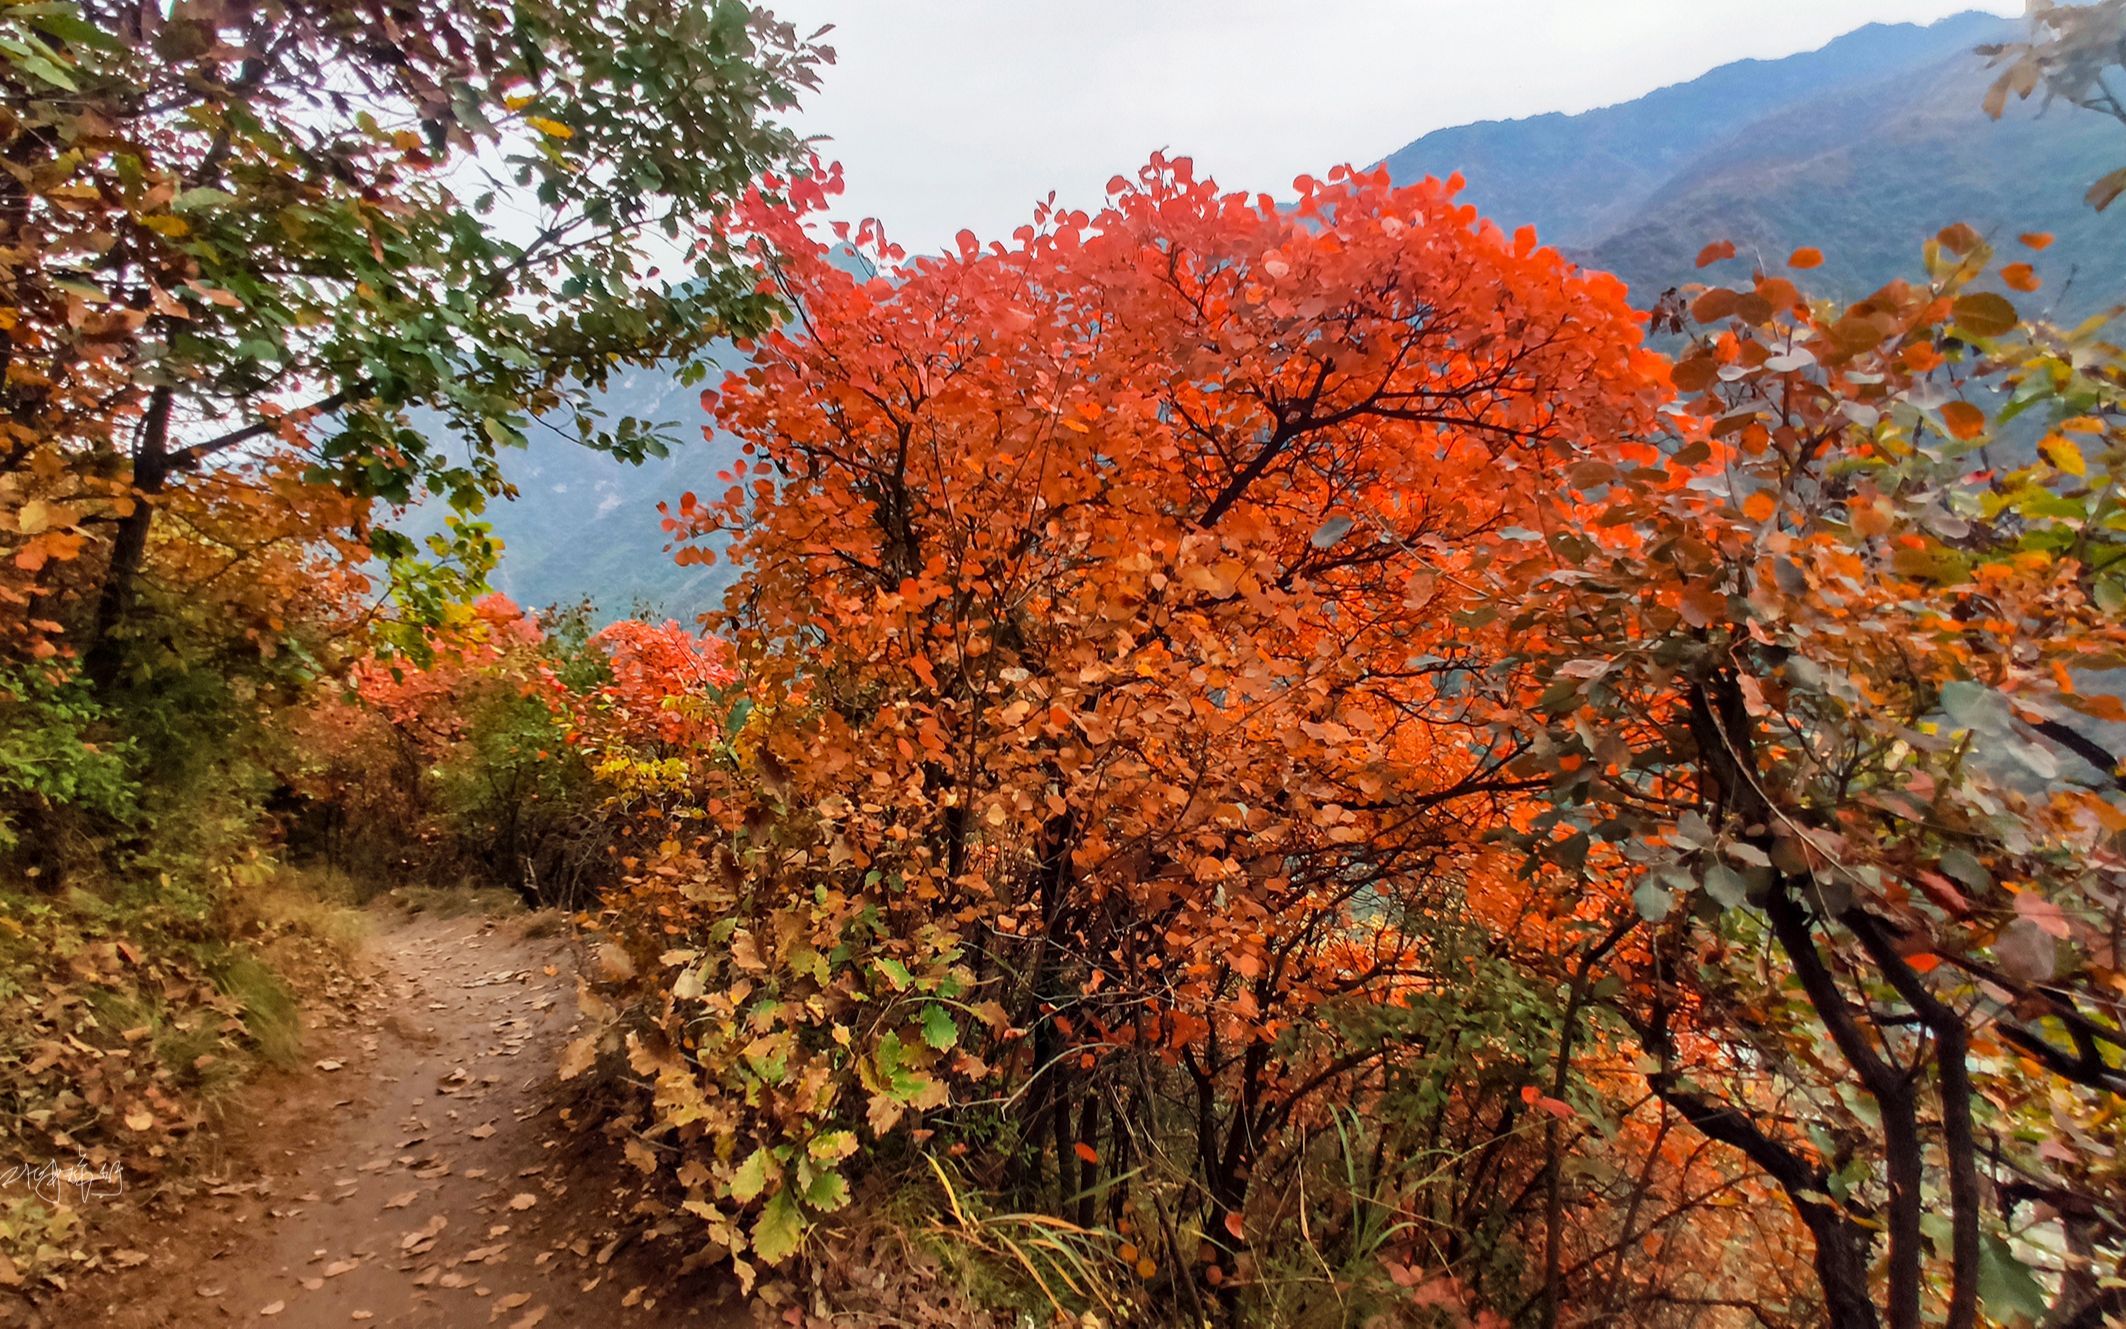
[1386, 13, 2007, 247]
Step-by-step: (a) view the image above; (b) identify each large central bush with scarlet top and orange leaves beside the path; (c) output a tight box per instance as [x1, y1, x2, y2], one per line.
[552, 149, 1862, 1323]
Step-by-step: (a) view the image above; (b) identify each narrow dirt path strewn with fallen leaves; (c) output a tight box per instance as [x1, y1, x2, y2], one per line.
[47, 912, 753, 1329]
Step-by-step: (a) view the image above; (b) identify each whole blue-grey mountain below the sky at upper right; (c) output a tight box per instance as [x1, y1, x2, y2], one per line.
[1384, 11, 2126, 317]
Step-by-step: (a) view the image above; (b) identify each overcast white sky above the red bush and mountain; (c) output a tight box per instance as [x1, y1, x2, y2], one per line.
[770, 0, 2022, 251]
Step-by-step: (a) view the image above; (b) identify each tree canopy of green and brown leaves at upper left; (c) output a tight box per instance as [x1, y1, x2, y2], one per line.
[0, 0, 831, 671]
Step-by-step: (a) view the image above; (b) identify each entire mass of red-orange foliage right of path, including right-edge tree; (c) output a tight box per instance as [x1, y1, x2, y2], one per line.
[570, 157, 2126, 1327]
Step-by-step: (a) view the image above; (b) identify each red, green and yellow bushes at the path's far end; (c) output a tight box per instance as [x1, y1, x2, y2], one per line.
[289, 595, 731, 906]
